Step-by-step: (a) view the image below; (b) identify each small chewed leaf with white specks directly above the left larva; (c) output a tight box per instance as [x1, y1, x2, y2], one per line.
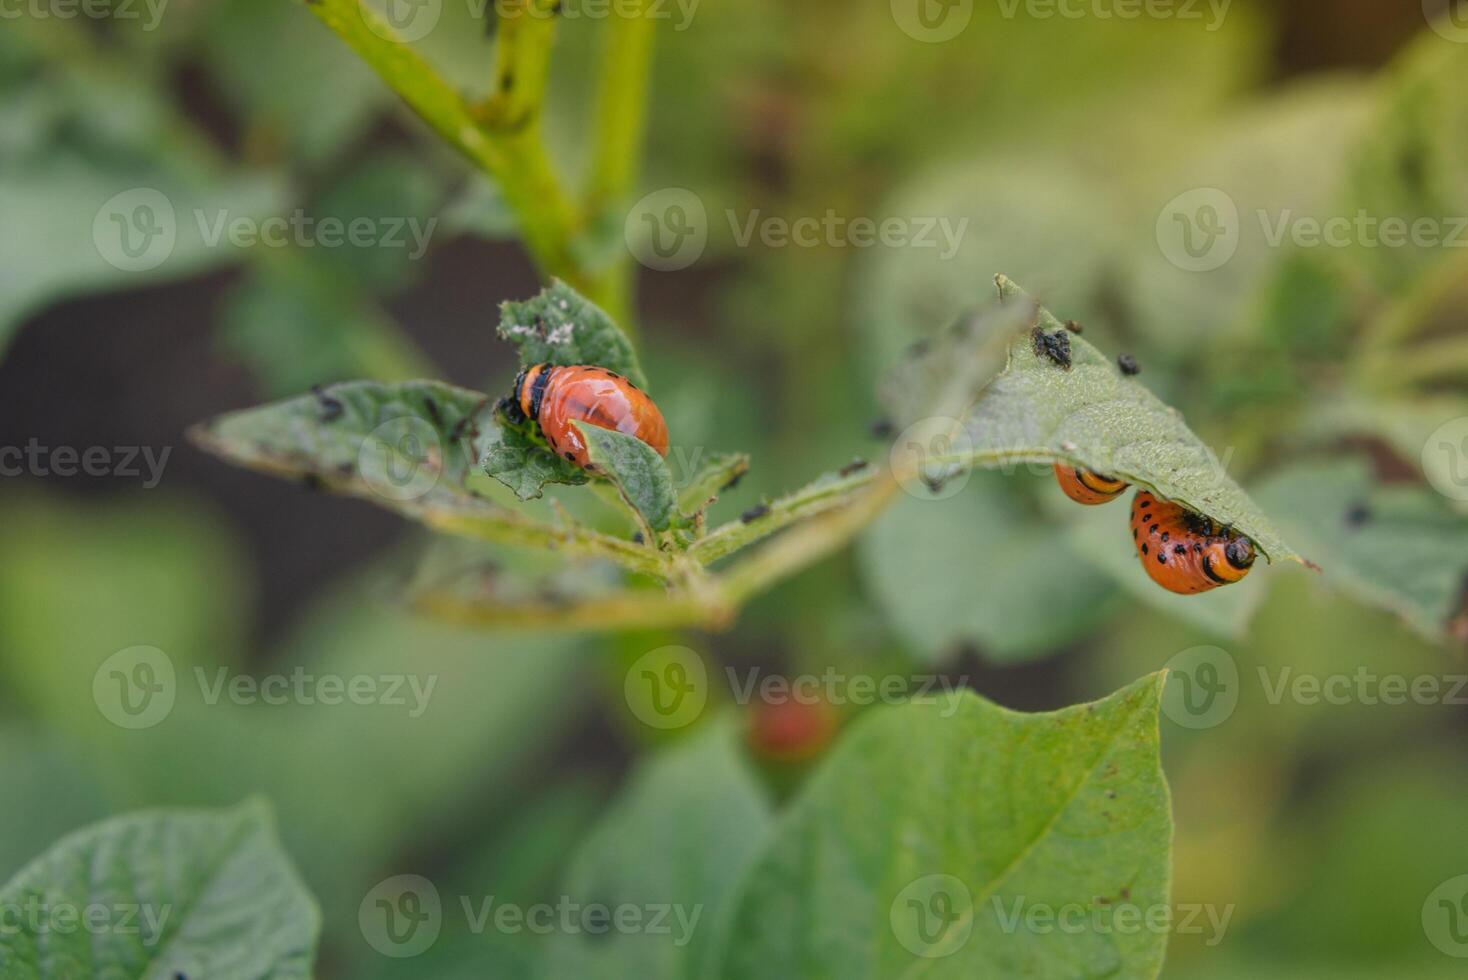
[499, 280, 647, 387]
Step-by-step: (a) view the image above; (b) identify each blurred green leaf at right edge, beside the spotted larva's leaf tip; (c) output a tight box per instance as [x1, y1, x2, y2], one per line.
[1260, 459, 1468, 643]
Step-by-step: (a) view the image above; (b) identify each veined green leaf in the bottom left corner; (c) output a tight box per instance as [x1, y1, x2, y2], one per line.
[0, 804, 320, 980]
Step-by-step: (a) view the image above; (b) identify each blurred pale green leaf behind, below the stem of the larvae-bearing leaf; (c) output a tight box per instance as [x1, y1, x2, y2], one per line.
[857, 472, 1115, 663]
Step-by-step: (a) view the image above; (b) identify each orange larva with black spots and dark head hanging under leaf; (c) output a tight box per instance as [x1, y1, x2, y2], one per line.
[1132, 490, 1254, 596]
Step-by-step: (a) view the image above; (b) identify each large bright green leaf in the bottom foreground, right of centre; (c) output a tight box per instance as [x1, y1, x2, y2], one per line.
[719, 673, 1173, 980]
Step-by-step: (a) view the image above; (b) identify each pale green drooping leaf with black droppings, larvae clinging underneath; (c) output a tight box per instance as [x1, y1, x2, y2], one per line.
[954, 276, 1305, 562]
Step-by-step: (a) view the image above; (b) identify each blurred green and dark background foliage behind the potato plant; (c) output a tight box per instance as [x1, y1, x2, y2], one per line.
[0, 0, 1468, 980]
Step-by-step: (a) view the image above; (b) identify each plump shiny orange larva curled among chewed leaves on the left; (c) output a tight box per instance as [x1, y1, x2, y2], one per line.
[511, 364, 668, 468]
